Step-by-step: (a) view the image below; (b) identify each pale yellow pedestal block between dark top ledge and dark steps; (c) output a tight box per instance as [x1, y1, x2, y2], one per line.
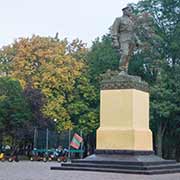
[96, 89, 153, 151]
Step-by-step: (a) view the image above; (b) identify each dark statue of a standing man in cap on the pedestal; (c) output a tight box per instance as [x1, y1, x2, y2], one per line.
[110, 6, 152, 73]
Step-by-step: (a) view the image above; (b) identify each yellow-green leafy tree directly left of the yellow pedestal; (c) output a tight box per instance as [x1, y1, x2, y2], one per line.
[67, 73, 99, 135]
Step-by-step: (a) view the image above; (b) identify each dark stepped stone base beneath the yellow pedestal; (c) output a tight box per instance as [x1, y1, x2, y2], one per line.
[51, 150, 180, 175]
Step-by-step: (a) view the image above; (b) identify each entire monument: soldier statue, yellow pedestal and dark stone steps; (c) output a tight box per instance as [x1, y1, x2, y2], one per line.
[51, 6, 180, 174]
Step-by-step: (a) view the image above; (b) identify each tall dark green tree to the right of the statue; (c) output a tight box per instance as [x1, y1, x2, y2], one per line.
[130, 0, 180, 156]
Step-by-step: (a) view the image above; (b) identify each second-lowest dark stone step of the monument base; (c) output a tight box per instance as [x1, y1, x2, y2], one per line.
[62, 163, 180, 170]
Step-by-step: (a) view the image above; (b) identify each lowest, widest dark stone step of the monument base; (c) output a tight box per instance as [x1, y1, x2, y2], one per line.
[51, 166, 180, 175]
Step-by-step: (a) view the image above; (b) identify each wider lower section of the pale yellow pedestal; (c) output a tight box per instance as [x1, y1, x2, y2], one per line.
[97, 127, 152, 151]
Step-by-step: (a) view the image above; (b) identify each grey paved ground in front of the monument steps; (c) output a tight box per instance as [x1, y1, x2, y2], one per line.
[0, 161, 180, 180]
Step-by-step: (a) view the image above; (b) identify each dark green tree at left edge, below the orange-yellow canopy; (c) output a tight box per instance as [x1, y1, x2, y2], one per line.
[0, 77, 32, 144]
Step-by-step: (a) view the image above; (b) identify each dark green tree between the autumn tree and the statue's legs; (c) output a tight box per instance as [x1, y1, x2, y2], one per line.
[87, 35, 119, 88]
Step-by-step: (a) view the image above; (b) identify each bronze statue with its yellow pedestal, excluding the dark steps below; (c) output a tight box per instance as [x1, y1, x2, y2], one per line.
[97, 6, 153, 151]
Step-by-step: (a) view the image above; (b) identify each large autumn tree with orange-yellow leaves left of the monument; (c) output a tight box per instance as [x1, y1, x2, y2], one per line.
[0, 36, 97, 130]
